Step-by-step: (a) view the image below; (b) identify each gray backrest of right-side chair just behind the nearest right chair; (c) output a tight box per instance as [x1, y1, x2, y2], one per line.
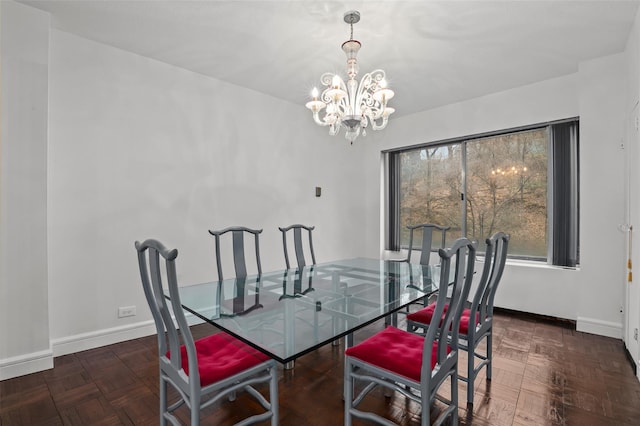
[469, 232, 510, 330]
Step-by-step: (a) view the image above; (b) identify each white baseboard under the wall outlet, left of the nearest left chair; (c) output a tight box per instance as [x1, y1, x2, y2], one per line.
[51, 320, 156, 356]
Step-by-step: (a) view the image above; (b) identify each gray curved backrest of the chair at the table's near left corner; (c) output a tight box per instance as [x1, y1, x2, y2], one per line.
[135, 239, 200, 395]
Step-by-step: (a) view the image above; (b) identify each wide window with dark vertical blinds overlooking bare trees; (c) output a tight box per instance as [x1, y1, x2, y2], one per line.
[387, 119, 578, 266]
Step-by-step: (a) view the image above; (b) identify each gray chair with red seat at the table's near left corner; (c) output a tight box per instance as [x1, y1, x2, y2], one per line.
[135, 239, 278, 426]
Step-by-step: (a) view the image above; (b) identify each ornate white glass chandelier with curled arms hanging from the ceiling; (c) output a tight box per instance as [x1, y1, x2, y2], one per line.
[306, 10, 395, 144]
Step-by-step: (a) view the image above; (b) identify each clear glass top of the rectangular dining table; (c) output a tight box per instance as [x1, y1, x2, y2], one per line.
[172, 258, 440, 363]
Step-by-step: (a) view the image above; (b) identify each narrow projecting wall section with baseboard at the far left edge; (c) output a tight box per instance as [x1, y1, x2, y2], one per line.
[0, 2, 53, 379]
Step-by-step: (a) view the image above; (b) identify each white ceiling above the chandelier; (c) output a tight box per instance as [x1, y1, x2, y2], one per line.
[19, 0, 640, 116]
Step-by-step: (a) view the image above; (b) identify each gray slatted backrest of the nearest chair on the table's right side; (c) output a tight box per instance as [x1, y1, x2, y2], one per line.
[422, 238, 478, 377]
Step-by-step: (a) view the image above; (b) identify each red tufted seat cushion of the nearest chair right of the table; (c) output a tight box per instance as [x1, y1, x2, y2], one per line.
[345, 326, 451, 382]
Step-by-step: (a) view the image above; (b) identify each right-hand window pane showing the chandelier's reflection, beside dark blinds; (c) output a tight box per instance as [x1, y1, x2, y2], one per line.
[466, 128, 548, 258]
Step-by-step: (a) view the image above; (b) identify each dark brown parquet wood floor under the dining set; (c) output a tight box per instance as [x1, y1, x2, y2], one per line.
[0, 312, 640, 426]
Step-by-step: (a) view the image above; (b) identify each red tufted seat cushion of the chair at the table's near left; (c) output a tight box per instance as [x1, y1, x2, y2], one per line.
[167, 333, 269, 386]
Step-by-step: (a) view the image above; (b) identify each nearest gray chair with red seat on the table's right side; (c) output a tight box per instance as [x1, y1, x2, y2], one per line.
[344, 238, 477, 426]
